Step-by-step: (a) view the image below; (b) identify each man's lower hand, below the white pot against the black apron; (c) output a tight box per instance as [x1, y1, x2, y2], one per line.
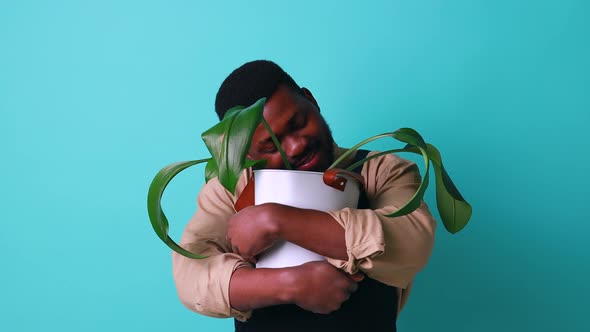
[292, 262, 364, 314]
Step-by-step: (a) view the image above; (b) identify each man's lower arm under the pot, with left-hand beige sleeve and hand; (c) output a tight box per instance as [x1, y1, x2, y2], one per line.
[173, 172, 362, 320]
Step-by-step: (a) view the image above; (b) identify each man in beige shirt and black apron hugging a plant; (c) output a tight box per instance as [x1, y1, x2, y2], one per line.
[173, 61, 436, 331]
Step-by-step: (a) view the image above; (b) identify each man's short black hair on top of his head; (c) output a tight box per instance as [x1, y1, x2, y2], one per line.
[215, 60, 301, 120]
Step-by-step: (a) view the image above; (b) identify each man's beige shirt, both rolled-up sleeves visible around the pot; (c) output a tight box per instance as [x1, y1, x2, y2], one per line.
[172, 149, 436, 321]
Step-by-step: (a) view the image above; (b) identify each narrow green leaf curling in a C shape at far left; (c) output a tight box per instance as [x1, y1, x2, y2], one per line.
[147, 158, 210, 259]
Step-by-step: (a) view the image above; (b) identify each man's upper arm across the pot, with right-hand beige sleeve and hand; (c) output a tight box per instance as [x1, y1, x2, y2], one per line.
[228, 155, 436, 288]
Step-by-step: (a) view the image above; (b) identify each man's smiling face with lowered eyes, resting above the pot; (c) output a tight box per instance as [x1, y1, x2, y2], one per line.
[248, 86, 334, 171]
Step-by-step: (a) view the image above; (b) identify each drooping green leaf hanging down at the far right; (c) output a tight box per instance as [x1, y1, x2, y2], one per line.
[404, 144, 472, 234]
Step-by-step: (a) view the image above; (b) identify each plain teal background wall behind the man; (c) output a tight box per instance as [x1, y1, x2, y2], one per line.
[0, 0, 590, 331]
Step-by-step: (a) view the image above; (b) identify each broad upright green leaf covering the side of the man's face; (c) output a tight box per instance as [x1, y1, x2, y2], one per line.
[201, 98, 266, 193]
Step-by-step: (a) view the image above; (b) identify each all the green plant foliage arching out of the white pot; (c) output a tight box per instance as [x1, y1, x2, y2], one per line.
[147, 98, 471, 259]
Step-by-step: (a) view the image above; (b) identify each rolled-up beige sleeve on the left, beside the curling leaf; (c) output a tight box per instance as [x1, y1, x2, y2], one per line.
[172, 177, 251, 321]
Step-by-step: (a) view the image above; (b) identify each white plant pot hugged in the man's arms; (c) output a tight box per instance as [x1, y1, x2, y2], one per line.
[254, 169, 360, 268]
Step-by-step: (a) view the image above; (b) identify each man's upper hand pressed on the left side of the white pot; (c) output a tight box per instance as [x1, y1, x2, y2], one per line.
[226, 203, 280, 263]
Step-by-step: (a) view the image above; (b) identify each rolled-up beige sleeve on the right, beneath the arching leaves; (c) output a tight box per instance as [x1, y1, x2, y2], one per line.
[327, 155, 436, 288]
